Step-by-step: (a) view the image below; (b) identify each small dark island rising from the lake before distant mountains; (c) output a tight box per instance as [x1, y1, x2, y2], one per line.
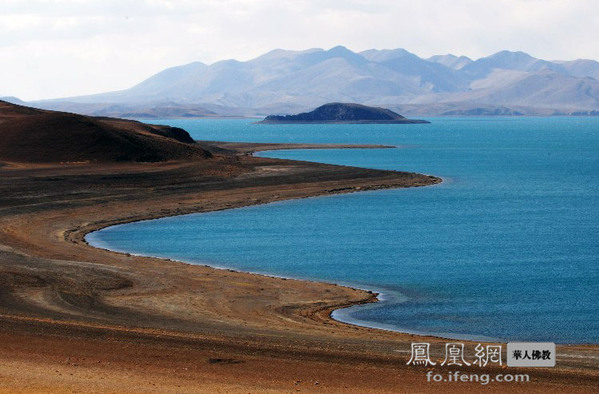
[257, 103, 430, 124]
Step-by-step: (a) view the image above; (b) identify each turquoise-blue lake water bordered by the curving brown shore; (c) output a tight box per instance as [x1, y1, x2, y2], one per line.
[88, 118, 599, 343]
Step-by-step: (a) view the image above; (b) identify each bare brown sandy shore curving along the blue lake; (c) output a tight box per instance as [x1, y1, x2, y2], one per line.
[0, 142, 599, 393]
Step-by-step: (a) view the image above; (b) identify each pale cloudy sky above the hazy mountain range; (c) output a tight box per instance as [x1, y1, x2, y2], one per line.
[0, 0, 599, 100]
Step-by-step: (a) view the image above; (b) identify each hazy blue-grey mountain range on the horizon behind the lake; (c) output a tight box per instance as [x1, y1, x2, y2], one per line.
[7, 46, 599, 117]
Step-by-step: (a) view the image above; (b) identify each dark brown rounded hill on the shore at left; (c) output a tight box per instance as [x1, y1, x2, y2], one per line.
[0, 101, 212, 163]
